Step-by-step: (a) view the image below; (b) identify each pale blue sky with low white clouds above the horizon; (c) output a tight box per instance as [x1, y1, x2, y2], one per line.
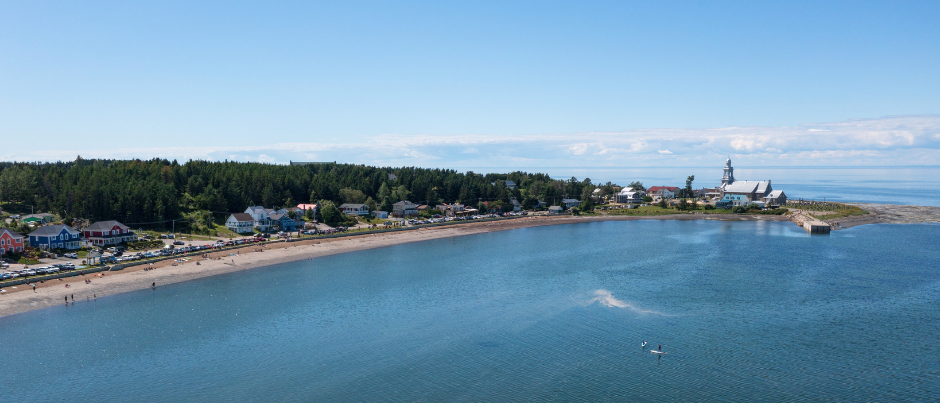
[0, 1, 940, 167]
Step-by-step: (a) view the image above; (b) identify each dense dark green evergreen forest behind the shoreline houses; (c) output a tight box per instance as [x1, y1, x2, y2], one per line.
[0, 157, 611, 232]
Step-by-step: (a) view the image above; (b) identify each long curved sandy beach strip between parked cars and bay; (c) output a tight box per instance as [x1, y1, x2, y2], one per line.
[0, 209, 940, 317]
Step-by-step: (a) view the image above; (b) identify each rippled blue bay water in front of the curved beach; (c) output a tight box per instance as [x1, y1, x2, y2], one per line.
[0, 221, 940, 402]
